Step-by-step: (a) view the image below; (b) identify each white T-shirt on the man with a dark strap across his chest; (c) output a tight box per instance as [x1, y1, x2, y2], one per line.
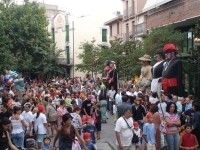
[115, 117, 134, 146]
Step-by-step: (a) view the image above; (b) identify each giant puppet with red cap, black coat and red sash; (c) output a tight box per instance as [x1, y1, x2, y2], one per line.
[162, 44, 184, 97]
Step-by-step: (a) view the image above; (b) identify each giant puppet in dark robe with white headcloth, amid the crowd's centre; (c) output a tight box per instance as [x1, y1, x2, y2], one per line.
[108, 61, 119, 92]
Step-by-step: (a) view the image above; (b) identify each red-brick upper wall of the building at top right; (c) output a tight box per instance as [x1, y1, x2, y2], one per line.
[147, 0, 200, 29]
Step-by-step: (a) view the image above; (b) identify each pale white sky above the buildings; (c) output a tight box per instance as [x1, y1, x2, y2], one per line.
[38, 0, 123, 16]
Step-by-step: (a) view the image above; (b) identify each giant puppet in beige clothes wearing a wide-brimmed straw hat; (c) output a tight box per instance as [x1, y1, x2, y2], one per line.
[138, 54, 152, 95]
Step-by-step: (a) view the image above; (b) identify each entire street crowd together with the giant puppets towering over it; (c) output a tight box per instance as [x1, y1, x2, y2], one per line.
[0, 44, 200, 150]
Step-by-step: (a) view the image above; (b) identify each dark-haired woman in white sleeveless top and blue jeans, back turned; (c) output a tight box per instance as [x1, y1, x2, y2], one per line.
[9, 106, 27, 148]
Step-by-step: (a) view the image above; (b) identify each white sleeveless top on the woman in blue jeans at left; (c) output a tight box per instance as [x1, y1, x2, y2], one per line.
[9, 115, 24, 134]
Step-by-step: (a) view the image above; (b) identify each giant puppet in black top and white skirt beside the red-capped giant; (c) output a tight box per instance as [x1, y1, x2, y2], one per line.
[151, 48, 165, 98]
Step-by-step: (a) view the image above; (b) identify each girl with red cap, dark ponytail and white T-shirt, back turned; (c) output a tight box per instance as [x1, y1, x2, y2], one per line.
[33, 105, 49, 149]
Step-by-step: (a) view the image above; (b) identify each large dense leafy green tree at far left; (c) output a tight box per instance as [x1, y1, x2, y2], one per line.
[0, 0, 60, 75]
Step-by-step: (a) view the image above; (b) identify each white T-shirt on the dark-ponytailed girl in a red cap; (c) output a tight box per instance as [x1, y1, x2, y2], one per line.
[33, 113, 47, 134]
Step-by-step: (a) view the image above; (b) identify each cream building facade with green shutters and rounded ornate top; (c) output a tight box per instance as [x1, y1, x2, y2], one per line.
[42, 4, 117, 77]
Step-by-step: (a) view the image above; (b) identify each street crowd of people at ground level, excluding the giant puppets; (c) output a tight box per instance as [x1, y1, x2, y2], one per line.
[0, 78, 200, 150]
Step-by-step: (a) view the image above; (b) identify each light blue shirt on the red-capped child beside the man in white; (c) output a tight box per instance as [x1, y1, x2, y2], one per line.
[143, 123, 156, 144]
